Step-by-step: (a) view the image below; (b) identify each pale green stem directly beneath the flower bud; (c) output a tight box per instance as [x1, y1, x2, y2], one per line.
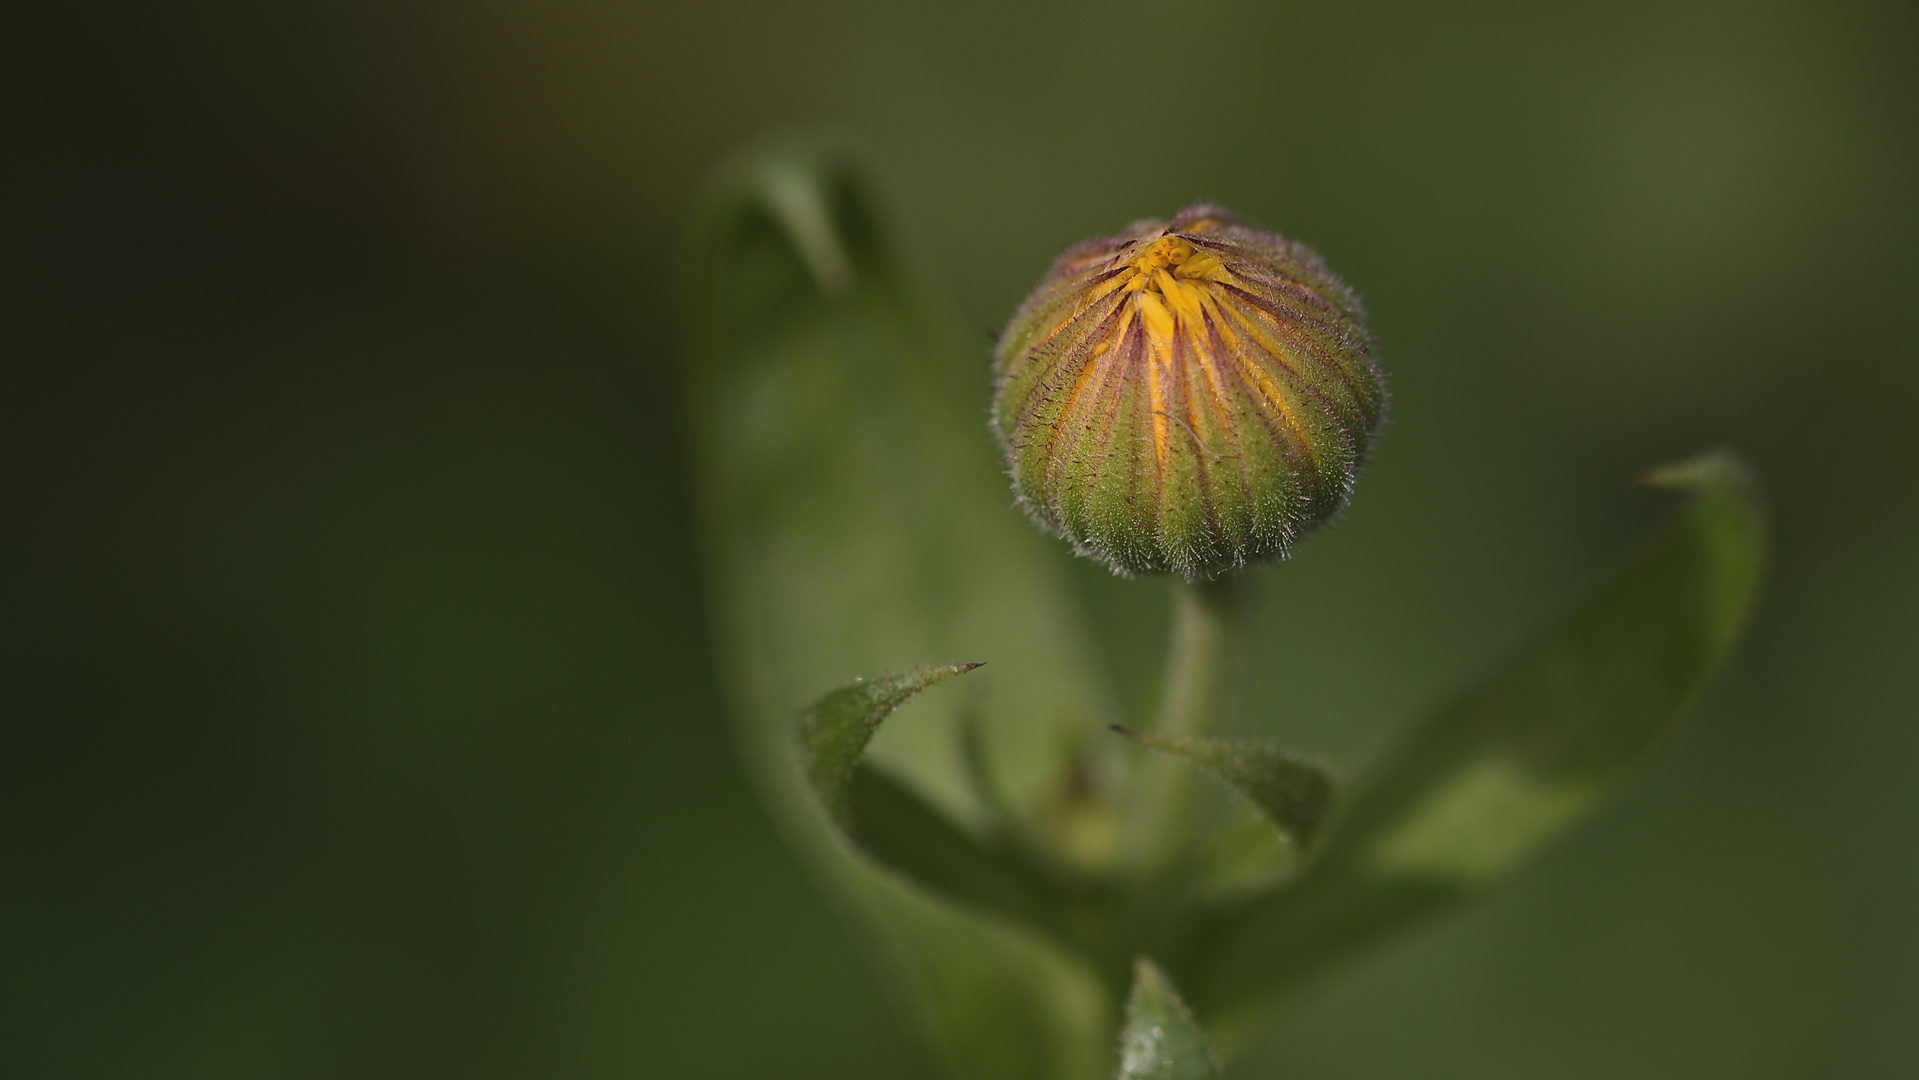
[1146, 574, 1251, 867]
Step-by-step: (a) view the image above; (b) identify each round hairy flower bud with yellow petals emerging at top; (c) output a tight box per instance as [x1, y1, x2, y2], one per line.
[992, 205, 1386, 581]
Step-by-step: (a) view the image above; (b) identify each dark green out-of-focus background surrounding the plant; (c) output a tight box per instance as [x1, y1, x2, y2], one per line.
[14, 0, 1919, 1080]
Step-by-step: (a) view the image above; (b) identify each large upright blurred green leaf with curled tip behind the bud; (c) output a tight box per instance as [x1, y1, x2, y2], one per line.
[683, 140, 1119, 1080]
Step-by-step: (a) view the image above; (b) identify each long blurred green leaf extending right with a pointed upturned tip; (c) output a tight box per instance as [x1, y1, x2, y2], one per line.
[1178, 453, 1764, 1021]
